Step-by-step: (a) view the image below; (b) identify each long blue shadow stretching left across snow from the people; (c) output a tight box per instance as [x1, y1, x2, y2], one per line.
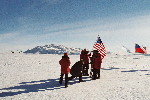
[0, 77, 91, 97]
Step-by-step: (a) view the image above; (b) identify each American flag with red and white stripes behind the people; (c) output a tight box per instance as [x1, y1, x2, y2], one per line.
[93, 37, 106, 59]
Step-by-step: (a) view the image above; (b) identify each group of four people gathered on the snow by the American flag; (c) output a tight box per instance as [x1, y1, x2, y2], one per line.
[59, 49, 102, 87]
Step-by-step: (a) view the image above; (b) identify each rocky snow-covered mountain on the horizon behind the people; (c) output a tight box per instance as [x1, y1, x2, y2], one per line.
[24, 44, 82, 55]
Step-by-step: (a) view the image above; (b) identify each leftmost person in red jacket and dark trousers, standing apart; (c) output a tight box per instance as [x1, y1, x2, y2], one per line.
[59, 53, 70, 87]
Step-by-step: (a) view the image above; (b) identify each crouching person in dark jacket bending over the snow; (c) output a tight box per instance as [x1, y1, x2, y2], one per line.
[69, 59, 84, 82]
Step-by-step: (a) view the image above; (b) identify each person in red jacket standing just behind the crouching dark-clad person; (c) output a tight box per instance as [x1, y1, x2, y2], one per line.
[80, 49, 91, 76]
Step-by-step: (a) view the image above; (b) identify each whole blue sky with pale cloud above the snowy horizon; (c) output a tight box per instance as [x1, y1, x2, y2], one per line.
[0, 0, 150, 52]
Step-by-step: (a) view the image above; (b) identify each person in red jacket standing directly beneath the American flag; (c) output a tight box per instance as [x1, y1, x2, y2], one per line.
[91, 50, 102, 80]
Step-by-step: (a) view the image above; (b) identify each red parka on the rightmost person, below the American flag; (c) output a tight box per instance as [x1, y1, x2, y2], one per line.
[92, 53, 102, 69]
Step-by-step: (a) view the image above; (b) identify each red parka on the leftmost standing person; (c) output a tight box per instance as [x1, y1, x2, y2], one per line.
[59, 58, 70, 74]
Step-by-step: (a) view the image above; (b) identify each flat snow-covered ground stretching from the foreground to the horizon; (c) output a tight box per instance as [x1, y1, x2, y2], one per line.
[0, 53, 150, 100]
